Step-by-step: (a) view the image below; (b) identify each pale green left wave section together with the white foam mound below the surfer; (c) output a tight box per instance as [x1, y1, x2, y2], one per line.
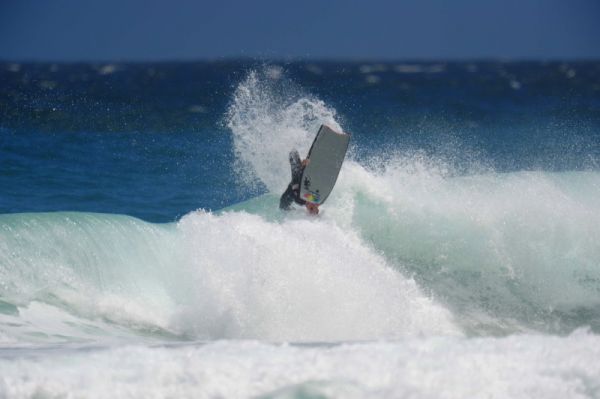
[0, 212, 460, 342]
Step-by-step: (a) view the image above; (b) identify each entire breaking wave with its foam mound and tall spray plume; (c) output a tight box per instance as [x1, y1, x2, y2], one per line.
[0, 65, 600, 343]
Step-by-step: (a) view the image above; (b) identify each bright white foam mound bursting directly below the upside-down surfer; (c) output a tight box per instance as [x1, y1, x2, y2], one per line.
[173, 213, 460, 341]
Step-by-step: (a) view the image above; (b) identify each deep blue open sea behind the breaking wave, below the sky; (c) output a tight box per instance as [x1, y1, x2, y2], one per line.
[0, 62, 600, 222]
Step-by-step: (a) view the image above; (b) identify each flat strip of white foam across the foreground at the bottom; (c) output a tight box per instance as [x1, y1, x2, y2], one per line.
[0, 331, 600, 399]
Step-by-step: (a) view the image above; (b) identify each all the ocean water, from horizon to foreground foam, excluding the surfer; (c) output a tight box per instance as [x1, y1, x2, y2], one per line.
[0, 61, 600, 398]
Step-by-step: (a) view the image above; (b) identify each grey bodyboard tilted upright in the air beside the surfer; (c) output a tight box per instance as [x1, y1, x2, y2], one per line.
[300, 125, 350, 205]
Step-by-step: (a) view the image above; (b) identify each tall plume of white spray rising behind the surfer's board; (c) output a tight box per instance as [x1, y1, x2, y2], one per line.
[225, 67, 341, 192]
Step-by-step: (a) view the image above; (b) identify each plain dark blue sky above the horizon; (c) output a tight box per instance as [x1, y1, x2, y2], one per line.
[0, 0, 600, 62]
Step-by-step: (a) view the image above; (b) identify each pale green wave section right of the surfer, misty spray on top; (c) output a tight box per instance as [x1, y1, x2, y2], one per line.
[330, 164, 600, 333]
